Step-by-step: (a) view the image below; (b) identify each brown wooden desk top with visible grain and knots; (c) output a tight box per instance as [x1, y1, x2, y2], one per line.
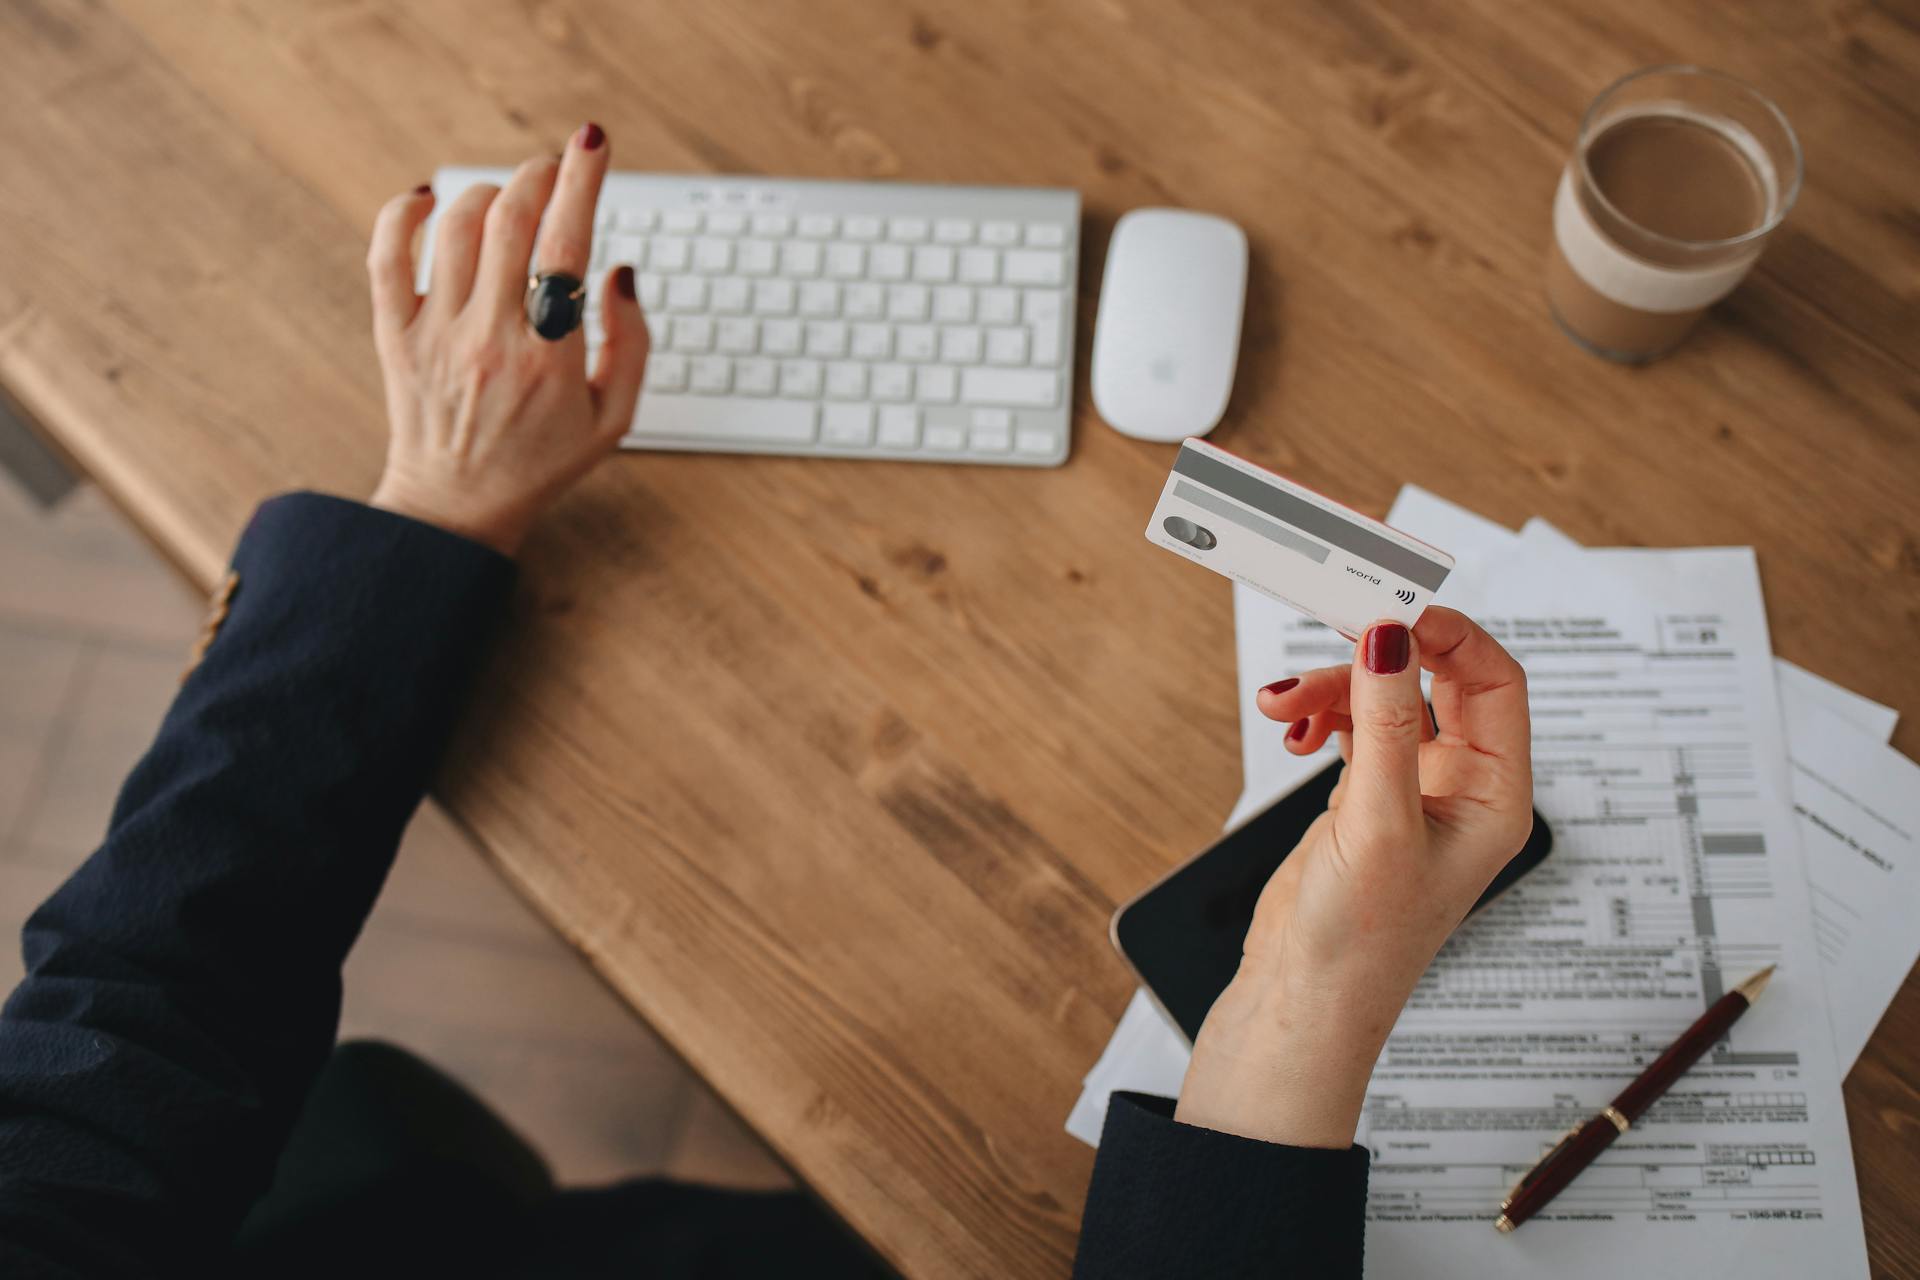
[0, 0, 1920, 1276]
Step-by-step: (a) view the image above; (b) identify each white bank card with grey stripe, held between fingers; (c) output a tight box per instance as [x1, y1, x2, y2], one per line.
[1146, 439, 1453, 639]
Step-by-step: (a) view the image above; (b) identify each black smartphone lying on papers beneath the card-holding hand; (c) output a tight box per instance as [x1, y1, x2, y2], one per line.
[1112, 762, 1553, 1040]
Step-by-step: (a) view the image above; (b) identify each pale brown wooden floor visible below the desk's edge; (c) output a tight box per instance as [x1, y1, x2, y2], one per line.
[0, 474, 789, 1188]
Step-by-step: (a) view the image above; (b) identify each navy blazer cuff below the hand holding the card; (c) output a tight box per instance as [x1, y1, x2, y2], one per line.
[1073, 1094, 1367, 1280]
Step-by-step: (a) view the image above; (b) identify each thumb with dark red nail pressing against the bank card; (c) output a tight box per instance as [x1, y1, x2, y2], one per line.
[1340, 622, 1428, 841]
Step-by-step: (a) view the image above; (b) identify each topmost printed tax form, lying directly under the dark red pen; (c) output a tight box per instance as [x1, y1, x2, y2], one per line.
[1359, 549, 1866, 1278]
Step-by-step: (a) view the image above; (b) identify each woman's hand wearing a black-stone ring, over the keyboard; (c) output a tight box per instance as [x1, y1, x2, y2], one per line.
[367, 125, 647, 555]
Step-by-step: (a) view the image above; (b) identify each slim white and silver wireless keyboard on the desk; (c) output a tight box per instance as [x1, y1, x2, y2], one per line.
[422, 169, 1079, 466]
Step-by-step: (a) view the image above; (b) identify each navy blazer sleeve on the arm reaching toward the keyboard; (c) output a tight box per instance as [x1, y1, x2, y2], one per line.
[0, 493, 513, 1276]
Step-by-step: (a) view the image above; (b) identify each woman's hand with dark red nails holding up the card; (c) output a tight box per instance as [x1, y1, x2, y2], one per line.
[1177, 606, 1532, 1148]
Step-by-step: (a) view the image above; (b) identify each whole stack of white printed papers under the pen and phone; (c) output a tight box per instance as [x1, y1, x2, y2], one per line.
[1068, 487, 1920, 1280]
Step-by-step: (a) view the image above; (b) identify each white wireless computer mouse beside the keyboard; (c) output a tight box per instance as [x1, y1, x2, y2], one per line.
[1092, 209, 1246, 441]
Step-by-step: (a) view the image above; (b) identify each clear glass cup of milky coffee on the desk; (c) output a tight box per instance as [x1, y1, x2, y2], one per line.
[1548, 67, 1803, 365]
